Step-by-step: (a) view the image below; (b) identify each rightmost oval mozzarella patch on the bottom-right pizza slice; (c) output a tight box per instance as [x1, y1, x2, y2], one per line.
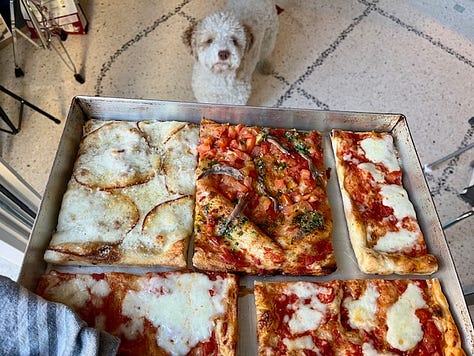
[387, 284, 426, 351]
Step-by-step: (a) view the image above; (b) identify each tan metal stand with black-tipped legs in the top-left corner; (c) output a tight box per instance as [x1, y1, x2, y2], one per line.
[10, 0, 85, 84]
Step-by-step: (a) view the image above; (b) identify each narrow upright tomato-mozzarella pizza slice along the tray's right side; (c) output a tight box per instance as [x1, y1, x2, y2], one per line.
[331, 130, 438, 274]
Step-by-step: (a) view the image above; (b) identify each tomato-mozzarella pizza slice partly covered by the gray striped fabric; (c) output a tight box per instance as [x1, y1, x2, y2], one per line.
[37, 271, 238, 355]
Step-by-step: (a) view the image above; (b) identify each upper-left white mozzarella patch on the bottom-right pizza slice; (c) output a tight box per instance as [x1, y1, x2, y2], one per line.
[288, 282, 328, 334]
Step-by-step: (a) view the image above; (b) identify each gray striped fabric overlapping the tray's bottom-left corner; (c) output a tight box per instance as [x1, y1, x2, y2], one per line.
[0, 276, 120, 356]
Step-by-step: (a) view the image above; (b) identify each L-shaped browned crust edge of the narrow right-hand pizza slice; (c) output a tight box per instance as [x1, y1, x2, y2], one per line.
[331, 130, 438, 275]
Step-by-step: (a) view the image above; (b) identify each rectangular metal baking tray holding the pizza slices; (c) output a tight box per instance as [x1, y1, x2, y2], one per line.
[19, 96, 474, 355]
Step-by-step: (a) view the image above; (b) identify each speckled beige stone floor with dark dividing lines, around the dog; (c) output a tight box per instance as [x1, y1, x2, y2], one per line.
[0, 0, 474, 318]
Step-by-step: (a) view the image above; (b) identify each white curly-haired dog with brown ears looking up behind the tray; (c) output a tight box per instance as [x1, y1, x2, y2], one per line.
[183, 0, 278, 105]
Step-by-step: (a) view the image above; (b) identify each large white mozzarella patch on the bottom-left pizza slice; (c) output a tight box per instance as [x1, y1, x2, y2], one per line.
[121, 274, 228, 354]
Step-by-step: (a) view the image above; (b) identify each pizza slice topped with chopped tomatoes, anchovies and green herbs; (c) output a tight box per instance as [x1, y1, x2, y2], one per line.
[193, 119, 336, 275]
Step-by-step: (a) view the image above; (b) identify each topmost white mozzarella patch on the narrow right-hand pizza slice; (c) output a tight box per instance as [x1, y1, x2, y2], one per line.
[360, 135, 400, 171]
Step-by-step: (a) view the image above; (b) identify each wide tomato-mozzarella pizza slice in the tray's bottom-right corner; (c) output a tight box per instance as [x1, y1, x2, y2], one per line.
[254, 279, 465, 355]
